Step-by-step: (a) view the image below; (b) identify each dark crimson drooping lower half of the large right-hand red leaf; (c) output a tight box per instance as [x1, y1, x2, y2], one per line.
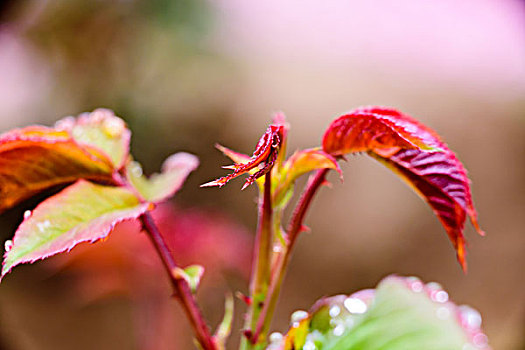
[369, 149, 484, 270]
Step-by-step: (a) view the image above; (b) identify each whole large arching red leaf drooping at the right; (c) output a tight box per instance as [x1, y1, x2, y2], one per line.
[323, 107, 483, 269]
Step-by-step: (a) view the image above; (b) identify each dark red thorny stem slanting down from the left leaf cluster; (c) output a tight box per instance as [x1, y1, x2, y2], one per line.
[140, 212, 217, 350]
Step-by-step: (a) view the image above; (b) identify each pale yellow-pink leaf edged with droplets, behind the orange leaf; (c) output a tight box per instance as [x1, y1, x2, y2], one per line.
[56, 109, 131, 169]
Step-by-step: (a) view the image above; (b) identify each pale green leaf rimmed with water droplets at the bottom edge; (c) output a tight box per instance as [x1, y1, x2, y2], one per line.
[274, 277, 490, 350]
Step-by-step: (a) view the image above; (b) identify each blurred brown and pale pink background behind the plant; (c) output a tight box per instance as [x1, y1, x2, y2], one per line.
[0, 0, 525, 350]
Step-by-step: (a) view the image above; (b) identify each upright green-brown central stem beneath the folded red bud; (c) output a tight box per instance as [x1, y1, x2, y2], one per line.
[241, 171, 273, 349]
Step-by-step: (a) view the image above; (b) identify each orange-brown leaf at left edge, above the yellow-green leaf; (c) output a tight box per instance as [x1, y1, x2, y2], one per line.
[0, 126, 113, 211]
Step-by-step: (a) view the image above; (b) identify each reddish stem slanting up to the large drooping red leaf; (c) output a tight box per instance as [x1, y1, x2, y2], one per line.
[253, 169, 329, 339]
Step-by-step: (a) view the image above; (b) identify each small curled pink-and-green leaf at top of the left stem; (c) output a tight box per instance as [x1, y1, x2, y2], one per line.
[126, 152, 199, 203]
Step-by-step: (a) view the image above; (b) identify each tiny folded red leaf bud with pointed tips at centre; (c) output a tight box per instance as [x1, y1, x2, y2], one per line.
[201, 124, 284, 189]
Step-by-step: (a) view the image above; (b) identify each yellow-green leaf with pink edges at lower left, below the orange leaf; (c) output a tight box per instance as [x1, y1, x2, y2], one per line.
[1, 180, 150, 277]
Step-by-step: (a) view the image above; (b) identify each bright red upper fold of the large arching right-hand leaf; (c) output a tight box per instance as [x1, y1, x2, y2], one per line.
[323, 107, 439, 156]
